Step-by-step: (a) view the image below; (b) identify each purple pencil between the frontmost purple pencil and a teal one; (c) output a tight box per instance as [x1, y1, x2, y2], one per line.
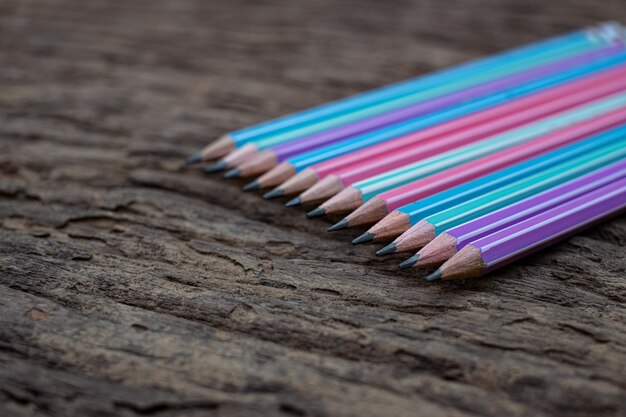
[403, 160, 626, 268]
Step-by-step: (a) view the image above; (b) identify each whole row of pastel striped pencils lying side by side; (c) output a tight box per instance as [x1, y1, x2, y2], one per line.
[187, 23, 626, 280]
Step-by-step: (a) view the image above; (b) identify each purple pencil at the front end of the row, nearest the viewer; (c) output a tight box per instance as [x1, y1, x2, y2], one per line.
[426, 174, 626, 281]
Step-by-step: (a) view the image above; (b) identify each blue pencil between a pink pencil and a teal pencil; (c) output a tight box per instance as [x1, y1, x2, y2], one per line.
[366, 125, 626, 252]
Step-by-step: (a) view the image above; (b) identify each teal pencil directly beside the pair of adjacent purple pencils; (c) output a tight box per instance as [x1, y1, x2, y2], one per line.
[390, 138, 626, 254]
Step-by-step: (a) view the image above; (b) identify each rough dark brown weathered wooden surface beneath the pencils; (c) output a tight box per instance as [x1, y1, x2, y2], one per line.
[0, 0, 626, 417]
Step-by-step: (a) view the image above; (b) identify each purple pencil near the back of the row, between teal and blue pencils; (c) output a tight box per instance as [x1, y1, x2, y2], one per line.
[239, 44, 624, 176]
